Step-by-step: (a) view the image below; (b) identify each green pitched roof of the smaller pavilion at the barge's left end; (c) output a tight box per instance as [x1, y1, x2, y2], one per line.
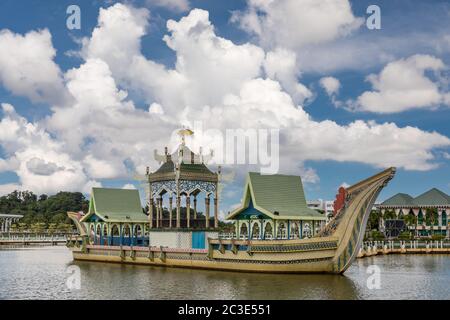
[82, 188, 147, 222]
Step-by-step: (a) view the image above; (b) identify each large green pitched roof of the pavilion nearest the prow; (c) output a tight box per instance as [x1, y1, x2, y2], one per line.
[227, 172, 325, 220]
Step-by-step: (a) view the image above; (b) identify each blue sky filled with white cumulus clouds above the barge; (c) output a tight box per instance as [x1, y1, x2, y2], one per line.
[0, 0, 450, 215]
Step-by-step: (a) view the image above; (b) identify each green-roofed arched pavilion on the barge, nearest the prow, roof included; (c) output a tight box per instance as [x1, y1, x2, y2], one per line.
[226, 172, 326, 239]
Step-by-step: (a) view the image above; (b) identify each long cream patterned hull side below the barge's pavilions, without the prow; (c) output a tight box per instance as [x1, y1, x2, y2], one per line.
[71, 238, 337, 273]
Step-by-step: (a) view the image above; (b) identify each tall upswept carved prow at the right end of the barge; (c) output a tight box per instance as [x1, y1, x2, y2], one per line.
[320, 167, 395, 273]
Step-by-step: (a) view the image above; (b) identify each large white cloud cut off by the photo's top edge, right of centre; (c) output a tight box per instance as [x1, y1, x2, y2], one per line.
[232, 0, 363, 49]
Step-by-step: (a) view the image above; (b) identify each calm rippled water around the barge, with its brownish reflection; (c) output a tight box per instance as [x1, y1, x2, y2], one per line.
[0, 247, 450, 299]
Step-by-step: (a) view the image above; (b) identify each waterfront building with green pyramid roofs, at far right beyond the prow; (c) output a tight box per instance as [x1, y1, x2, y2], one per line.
[378, 188, 450, 237]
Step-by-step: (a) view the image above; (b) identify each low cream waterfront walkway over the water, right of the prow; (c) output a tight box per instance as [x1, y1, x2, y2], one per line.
[357, 240, 450, 258]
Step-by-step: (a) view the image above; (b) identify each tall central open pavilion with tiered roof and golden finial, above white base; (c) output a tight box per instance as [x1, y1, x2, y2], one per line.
[147, 129, 220, 229]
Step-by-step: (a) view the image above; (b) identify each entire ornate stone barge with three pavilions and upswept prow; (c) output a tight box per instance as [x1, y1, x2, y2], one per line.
[67, 131, 395, 274]
